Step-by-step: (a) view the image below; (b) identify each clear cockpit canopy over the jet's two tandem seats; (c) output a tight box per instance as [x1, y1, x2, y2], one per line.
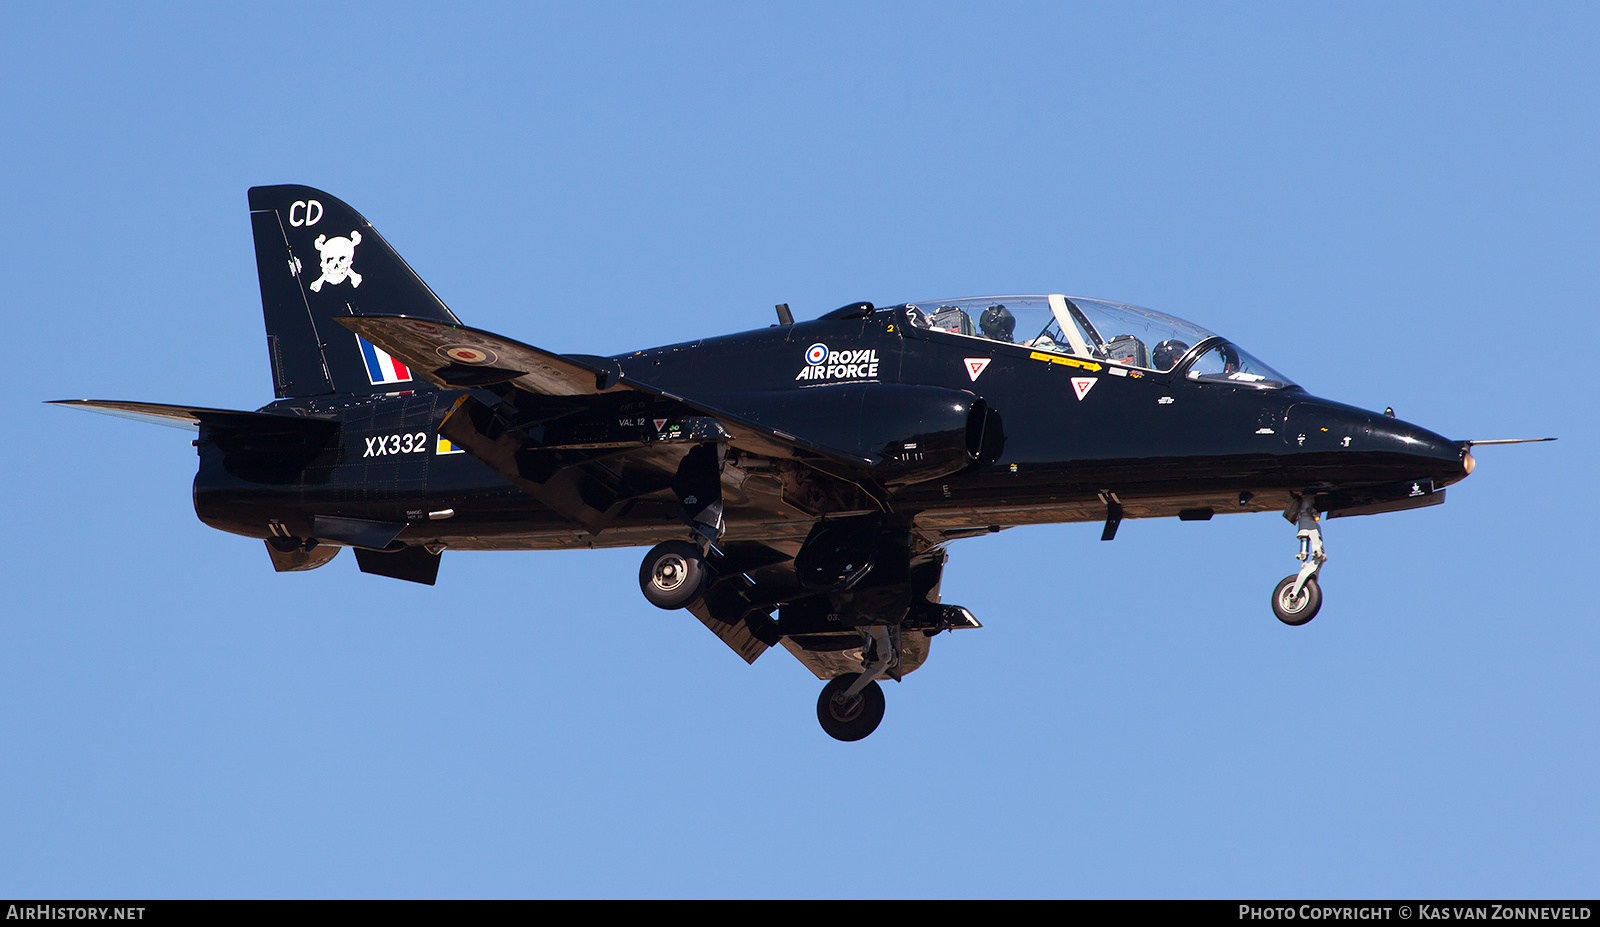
[906, 295, 1294, 389]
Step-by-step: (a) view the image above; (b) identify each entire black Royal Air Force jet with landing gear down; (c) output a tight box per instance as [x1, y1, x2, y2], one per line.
[56, 186, 1542, 740]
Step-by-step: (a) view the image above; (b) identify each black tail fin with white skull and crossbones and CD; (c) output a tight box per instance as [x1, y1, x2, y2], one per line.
[250, 184, 461, 399]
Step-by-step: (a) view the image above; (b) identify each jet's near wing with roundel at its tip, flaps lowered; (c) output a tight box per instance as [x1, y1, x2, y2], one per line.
[339, 315, 902, 661]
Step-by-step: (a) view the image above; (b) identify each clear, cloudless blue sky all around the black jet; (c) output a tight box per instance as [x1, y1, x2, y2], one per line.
[0, 3, 1600, 898]
